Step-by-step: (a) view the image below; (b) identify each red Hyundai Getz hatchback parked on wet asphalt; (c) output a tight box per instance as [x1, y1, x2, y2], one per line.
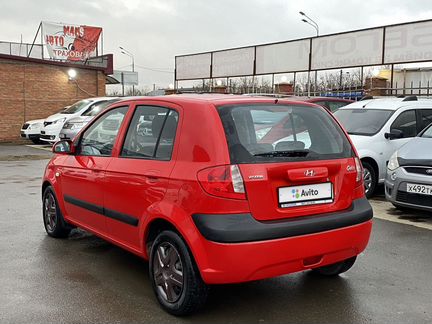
[42, 95, 372, 315]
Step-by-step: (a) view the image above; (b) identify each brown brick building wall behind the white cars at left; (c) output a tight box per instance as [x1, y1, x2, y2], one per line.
[0, 59, 105, 142]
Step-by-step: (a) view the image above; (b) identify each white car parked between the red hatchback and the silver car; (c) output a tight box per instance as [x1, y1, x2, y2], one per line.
[334, 96, 432, 197]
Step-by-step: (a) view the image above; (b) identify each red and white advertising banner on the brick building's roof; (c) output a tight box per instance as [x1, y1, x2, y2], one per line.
[42, 22, 102, 61]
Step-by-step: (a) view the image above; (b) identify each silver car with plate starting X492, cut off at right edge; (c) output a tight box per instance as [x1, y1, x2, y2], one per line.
[385, 124, 432, 211]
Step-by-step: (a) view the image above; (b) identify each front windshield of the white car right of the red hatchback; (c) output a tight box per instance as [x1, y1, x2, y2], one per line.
[334, 108, 393, 136]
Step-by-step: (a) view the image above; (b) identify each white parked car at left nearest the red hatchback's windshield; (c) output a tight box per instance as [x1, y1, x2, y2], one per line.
[59, 98, 119, 139]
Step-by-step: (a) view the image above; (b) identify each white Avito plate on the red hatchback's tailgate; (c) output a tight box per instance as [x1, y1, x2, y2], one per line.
[278, 182, 333, 208]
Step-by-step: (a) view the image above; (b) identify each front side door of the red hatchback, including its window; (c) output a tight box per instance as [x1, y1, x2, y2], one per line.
[60, 106, 128, 233]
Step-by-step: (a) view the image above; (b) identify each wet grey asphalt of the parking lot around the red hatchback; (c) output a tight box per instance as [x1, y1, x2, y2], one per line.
[0, 146, 432, 323]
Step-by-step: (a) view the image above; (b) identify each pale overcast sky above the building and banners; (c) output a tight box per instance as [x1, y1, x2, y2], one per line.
[0, 0, 432, 87]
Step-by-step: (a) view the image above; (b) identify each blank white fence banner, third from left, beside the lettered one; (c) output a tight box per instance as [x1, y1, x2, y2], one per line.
[256, 39, 310, 74]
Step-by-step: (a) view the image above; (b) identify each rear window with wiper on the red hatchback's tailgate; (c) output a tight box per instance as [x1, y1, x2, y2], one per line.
[218, 104, 353, 163]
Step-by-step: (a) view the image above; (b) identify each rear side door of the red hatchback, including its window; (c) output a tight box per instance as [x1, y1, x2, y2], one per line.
[104, 104, 179, 251]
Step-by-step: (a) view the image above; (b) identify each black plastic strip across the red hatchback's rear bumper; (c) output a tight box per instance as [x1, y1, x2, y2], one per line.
[192, 198, 373, 243]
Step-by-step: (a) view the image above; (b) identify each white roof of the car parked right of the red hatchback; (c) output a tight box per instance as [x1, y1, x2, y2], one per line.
[339, 98, 432, 111]
